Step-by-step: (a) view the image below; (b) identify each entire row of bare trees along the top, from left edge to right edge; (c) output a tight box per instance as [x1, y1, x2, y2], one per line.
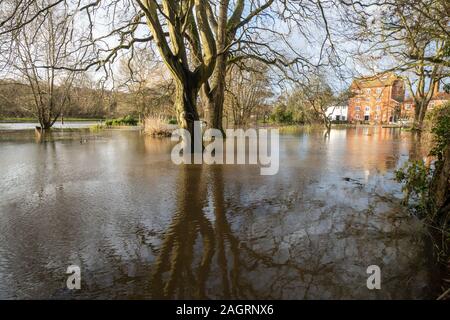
[0, 0, 450, 132]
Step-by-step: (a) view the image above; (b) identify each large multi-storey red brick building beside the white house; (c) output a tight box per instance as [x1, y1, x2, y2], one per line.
[348, 73, 405, 124]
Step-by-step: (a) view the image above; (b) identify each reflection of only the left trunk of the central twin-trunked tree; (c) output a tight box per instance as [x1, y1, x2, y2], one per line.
[152, 165, 215, 298]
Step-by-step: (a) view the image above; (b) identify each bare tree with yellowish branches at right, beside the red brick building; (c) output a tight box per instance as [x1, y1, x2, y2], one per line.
[349, 0, 450, 130]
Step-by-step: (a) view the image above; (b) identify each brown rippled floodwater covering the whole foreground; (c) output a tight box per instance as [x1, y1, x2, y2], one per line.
[0, 127, 437, 299]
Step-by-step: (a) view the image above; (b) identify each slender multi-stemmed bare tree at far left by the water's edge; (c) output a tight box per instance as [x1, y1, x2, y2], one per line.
[4, 4, 83, 129]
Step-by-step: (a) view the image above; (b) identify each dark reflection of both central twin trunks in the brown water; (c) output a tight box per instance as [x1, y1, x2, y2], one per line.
[151, 165, 272, 299]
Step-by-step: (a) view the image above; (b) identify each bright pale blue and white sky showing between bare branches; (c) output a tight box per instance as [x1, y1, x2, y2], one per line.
[1, 0, 446, 94]
